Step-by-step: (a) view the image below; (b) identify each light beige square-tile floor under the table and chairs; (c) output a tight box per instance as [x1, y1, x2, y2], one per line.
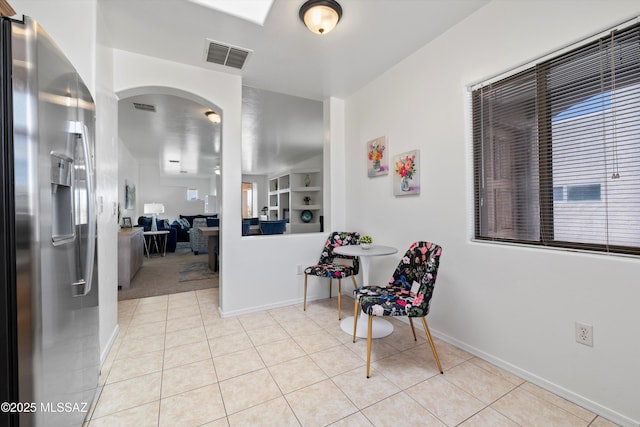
[88, 289, 614, 427]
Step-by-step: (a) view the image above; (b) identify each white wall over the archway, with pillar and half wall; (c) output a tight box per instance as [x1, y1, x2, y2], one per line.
[114, 50, 326, 316]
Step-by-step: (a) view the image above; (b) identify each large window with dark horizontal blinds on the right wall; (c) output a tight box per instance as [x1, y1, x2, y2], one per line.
[472, 20, 640, 254]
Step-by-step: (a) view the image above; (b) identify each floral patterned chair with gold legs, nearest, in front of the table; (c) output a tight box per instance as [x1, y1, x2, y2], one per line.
[353, 242, 443, 378]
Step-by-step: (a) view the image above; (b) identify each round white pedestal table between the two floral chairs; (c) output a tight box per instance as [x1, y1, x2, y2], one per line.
[333, 245, 398, 338]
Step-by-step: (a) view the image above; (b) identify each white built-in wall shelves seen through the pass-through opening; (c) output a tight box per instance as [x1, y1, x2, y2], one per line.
[269, 169, 323, 233]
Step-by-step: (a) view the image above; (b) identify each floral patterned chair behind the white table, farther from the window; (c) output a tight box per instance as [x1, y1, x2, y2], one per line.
[304, 231, 360, 320]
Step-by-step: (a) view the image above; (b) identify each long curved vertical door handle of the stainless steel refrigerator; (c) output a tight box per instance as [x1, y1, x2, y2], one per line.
[69, 122, 96, 296]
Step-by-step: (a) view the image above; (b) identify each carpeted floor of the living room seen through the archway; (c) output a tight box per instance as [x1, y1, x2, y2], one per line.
[118, 245, 218, 301]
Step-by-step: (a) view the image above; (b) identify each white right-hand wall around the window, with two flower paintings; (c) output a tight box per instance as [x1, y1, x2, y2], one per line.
[344, 0, 640, 425]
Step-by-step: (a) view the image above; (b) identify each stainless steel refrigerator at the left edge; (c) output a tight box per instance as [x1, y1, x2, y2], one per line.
[0, 17, 99, 427]
